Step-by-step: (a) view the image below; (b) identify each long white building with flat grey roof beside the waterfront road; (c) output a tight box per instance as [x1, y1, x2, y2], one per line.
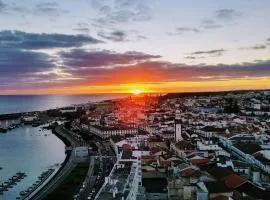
[95, 149, 145, 200]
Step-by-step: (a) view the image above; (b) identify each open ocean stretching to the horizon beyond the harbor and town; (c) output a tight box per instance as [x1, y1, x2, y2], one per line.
[0, 94, 126, 114]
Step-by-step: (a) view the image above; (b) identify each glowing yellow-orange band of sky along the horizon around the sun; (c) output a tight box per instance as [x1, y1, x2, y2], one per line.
[3, 77, 270, 94]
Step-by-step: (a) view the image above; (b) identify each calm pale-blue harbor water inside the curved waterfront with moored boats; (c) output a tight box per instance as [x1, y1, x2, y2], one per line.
[0, 120, 66, 199]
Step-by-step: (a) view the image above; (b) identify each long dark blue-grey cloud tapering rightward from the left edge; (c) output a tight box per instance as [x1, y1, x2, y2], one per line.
[0, 30, 102, 49]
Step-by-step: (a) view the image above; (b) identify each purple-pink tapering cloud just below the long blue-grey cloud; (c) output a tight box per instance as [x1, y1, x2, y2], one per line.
[59, 49, 160, 68]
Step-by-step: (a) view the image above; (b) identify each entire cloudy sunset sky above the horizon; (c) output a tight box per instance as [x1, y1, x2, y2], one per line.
[0, 0, 270, 94]
